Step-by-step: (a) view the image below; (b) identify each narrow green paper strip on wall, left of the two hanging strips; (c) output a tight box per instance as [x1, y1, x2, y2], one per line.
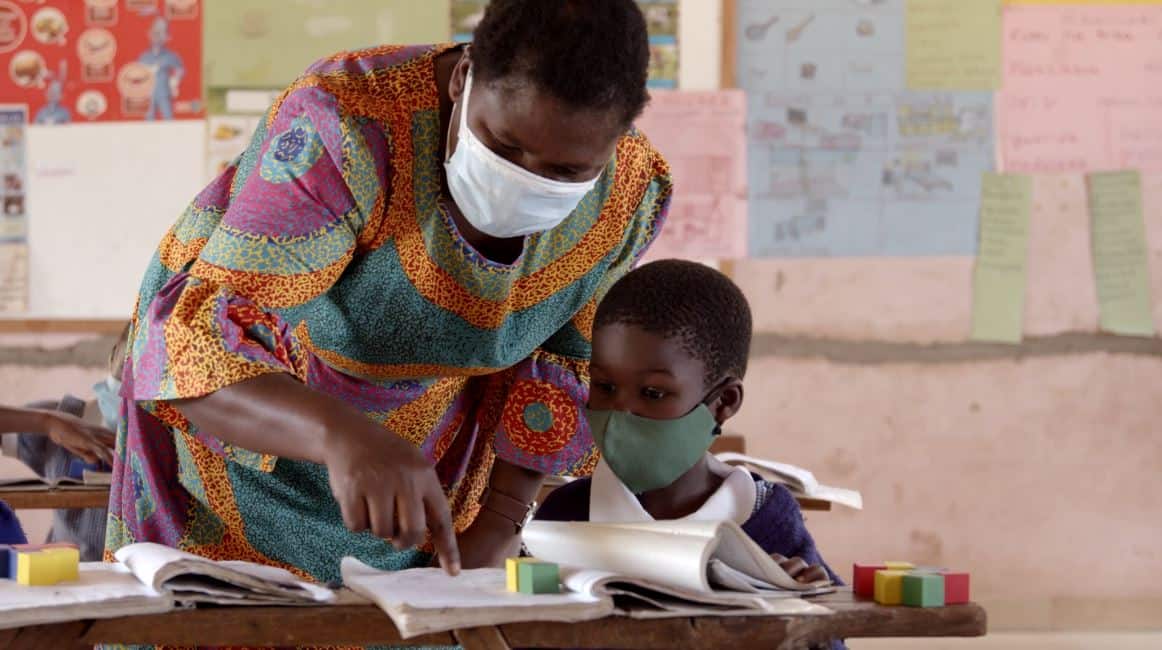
[971, 173, 1033, 343]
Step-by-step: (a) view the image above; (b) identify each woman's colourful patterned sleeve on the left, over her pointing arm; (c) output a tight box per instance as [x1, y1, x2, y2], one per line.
[131, 87, 386, 469]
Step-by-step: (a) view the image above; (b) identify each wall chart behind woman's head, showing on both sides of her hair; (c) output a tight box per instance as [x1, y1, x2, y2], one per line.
[451, 0, 680, 88]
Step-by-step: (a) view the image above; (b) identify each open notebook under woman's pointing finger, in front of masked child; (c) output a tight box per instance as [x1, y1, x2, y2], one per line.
[342, 521, 833, 638]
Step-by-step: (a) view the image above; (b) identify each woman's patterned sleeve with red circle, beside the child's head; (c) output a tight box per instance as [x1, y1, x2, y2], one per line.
[494, 165, 672, 476]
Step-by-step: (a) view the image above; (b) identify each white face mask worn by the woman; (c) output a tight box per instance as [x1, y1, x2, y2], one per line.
[444, 70, 601, 238]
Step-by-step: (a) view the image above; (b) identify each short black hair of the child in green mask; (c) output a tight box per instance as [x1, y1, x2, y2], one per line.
[594, 259, 753, 386]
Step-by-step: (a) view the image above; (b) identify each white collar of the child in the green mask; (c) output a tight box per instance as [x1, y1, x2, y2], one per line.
[589, 459, 758, 526]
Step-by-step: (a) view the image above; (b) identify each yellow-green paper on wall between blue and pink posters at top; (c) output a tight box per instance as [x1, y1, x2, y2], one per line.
[905, 0, 1000, 91]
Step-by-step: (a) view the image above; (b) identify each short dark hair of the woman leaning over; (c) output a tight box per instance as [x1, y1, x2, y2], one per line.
[472, 0, 650, 127]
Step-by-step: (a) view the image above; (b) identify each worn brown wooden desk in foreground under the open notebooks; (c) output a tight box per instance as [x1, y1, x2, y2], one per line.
[0, 591, 987, 650]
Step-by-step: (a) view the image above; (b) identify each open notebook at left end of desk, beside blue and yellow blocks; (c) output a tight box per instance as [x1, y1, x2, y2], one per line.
[0, 544, 336, 629]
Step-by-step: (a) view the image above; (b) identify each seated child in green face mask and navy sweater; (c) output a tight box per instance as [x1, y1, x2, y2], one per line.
[536, 259, 841, 584]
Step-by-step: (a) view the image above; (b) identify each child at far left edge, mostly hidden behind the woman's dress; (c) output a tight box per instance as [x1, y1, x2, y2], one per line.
[0, 326, 129, 562]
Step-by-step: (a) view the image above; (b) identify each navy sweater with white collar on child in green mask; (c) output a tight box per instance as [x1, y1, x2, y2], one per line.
[536, 460, 842, 585]
